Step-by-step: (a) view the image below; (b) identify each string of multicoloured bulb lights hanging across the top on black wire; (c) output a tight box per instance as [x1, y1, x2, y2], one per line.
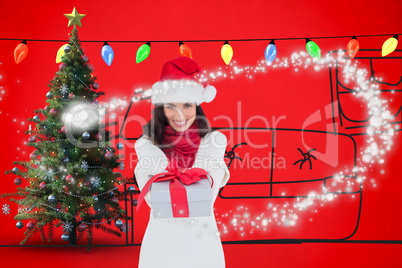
[0, 34, 400, 66]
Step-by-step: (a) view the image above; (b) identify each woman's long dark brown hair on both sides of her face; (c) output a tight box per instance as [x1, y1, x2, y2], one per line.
[143, 103, 211, 148]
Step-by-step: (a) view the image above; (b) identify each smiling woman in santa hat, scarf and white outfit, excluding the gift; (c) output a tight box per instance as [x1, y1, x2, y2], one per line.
[134, 57, 229, 268]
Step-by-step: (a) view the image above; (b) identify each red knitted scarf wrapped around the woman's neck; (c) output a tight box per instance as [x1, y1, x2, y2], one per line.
[162, 121, 201, 169]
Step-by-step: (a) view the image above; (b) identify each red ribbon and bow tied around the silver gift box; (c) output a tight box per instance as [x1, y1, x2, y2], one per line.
[137, 158, 213, 218]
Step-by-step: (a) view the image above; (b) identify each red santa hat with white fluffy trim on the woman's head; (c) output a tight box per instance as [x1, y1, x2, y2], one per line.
[151, 57, 216, 105]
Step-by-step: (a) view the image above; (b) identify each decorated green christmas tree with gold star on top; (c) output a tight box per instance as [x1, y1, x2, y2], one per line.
[2, 8, 125, 245]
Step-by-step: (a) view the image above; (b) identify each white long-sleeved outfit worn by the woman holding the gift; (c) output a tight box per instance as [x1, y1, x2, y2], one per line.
[134, 131, 230, 268]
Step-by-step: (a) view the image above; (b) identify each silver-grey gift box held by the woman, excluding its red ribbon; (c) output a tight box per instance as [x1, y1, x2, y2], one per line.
[151, 179, 212, 218]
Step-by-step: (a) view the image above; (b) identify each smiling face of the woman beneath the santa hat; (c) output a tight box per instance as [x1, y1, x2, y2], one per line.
[163, 102, 196, 132]
